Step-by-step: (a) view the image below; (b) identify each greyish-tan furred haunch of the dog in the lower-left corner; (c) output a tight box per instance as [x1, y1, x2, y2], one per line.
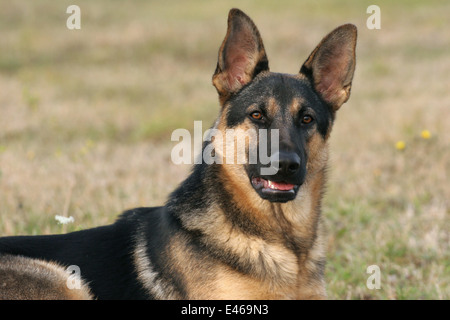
[0, 255, 93, 300]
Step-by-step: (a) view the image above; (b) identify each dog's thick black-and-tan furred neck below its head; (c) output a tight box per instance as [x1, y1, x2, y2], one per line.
[167, 164, 326, 274]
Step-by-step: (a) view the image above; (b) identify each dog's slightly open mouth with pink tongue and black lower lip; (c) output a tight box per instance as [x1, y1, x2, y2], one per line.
[251, 177, 299, 202]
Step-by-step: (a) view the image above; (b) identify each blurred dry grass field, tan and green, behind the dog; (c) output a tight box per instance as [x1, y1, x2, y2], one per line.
[0, 0, 450, 299]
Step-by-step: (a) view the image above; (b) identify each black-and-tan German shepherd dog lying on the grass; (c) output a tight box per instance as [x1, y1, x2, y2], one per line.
[0, 9, 357, 299]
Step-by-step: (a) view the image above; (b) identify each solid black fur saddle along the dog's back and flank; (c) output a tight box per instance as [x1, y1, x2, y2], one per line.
[0, 208, 151, 299]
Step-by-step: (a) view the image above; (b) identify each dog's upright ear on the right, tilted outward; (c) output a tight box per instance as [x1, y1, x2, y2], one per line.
[300, 24, 357, 111]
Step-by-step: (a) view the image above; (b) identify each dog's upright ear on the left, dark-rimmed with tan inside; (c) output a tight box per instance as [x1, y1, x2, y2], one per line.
[213, 9, 269, 105]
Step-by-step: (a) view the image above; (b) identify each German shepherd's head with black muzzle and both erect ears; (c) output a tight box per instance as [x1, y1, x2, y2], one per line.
[213, 9, 356, 202]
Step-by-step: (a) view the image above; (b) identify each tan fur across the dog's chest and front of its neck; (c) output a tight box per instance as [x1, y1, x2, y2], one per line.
[179, 170, 326, 299]
